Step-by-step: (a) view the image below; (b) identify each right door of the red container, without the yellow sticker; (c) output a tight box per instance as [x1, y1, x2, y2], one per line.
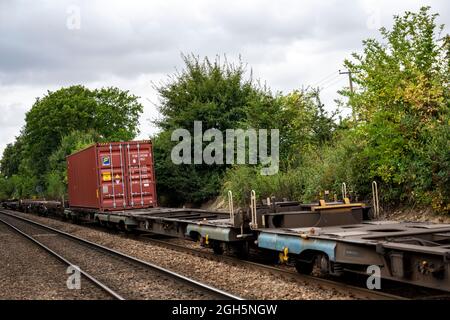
[124, 143, 156, 208]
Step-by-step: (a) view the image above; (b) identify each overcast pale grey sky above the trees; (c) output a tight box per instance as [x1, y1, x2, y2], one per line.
[0, 0, 450, 158]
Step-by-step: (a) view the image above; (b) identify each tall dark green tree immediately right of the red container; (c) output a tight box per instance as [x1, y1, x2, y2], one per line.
[153, 56, 264, 205]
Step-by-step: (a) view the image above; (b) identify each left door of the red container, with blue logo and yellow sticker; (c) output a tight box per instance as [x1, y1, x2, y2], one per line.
[98, 144, 127, 210]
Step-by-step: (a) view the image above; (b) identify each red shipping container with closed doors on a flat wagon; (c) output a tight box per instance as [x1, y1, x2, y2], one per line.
[67, 141, 157, 211]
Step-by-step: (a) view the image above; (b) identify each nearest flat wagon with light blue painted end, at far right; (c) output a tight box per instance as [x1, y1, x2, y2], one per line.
[257, 221, 450, 291]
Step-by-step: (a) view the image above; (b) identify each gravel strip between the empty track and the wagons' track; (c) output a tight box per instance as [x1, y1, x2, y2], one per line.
[7, 212, 355, 300]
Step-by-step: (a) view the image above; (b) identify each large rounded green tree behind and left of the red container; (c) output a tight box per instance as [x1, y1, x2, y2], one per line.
[0, 85, 143, 197]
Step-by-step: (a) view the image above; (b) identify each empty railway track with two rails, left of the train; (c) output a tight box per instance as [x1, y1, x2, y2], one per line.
[0, 210, 241, 300]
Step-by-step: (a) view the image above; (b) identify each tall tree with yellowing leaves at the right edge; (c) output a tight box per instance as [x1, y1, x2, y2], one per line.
[341, 7, 450, 210]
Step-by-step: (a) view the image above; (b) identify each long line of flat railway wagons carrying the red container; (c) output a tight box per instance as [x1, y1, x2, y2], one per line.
[6, 195, 450, 291]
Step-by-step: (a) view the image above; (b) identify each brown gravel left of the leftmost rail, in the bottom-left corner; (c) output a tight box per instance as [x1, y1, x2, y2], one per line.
[0, 223, 108, 300]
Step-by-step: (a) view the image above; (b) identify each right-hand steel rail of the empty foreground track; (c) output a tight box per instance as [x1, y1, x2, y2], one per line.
[0, 210, 244, 300]
